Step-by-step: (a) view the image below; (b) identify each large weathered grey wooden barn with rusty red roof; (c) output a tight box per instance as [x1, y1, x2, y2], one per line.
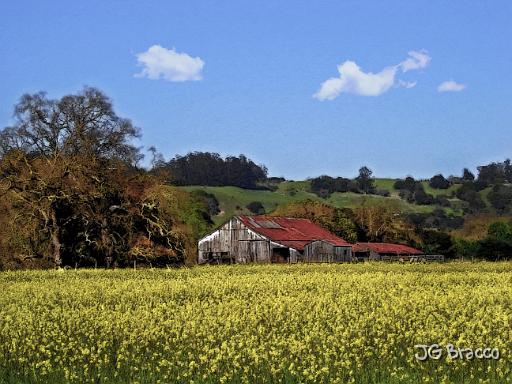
[198, 215, 352, 264]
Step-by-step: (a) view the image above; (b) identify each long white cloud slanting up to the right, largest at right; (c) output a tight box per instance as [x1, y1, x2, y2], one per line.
[313, 51, 430, 101]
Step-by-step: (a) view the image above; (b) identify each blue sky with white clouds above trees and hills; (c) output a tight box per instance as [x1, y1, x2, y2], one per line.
[0, 0, 512, 179]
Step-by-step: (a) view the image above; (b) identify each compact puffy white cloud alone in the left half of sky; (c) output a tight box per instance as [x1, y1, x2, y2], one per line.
[135, 45, 204, 81]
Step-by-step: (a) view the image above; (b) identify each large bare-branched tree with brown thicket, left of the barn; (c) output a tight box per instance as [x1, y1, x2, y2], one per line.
[0, 87, 211, 267]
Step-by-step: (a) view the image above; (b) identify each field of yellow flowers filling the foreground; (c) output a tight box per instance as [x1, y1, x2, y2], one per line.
[0, 263, 512, 383]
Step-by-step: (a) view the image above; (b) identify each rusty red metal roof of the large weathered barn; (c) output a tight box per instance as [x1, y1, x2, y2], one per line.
[238, 215, 351, 251]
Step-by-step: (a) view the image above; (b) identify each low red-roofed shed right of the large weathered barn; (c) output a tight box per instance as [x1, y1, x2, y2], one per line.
[352, 243, 424, 260]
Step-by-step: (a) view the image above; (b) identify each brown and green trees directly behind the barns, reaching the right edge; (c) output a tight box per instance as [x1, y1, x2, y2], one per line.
[272, 200, 512, 261]
